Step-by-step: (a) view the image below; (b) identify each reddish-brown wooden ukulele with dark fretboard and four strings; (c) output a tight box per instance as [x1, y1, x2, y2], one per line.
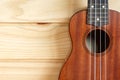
[59, 0, 120, 80]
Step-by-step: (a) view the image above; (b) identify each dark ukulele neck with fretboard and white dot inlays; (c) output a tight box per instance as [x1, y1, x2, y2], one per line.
[87, 0, 109, 27]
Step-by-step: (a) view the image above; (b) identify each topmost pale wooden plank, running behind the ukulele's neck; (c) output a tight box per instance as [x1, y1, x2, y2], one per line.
[0, 0, 120, 22]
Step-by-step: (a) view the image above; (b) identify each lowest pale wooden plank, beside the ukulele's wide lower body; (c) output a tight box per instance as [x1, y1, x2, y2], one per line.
[0, 60, 63, 80]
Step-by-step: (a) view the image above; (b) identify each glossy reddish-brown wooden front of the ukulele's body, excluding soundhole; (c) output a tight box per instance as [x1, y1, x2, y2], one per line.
[59, 10, 120, 80]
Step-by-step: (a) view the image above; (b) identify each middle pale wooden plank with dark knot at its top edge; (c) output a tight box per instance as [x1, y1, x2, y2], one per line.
[0, 24, 71, 60]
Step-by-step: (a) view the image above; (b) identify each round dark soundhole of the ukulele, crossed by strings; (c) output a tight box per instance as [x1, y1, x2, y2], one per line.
[86, 29, 110, 54]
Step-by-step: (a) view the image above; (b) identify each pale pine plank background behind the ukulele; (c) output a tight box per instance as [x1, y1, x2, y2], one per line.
[0, 0, 120, 80]
